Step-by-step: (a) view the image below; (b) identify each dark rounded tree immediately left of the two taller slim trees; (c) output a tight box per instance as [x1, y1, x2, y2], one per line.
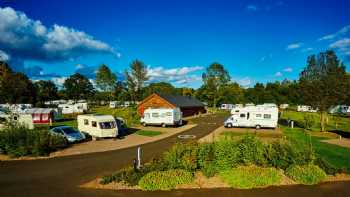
[63, 73, 94, 100]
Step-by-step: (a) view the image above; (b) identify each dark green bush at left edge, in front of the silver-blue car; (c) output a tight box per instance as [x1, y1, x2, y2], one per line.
[0, 125, 67, 157]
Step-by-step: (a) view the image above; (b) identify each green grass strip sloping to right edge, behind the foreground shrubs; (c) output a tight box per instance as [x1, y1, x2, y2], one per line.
[282, 127, 350, 172]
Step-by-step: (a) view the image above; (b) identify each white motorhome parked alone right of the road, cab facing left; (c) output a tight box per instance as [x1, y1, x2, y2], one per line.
[224, 106, 278, 129]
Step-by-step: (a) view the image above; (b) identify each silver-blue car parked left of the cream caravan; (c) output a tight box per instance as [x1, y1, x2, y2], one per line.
[50, 126, 86, 143]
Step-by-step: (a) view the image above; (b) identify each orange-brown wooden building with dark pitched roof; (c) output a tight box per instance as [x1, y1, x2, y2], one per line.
[137, 93, 206, 117]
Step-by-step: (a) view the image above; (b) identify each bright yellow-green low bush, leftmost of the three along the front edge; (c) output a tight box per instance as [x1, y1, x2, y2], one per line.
[139, 169, 193, 191]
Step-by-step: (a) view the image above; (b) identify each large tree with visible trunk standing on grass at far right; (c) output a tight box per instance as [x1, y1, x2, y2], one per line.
[299, 50, 347, 131]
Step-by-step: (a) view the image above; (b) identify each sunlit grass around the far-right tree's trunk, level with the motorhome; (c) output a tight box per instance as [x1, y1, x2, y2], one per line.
[281, 111, 350, 132]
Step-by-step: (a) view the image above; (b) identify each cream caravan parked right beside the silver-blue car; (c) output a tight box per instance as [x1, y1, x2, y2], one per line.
[77, 114, 118, 138]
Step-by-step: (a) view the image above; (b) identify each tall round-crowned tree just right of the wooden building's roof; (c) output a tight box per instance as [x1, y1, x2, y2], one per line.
[202, 63, 230, 107]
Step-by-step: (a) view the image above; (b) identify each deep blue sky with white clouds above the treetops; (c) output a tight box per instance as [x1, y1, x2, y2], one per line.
[0, 0, 350, 88]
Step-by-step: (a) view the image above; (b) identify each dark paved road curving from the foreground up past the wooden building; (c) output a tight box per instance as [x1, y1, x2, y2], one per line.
[0, 113, 350, 197]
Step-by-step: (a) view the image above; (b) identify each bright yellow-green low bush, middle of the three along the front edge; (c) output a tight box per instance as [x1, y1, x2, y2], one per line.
[220, 166, 283, 189]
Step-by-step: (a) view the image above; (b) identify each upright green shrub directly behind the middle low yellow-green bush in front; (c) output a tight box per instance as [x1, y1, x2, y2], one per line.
[237, 135, 267, 165]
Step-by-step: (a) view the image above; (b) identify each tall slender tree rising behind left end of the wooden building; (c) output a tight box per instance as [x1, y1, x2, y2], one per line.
[125, 60, 148, 101]
